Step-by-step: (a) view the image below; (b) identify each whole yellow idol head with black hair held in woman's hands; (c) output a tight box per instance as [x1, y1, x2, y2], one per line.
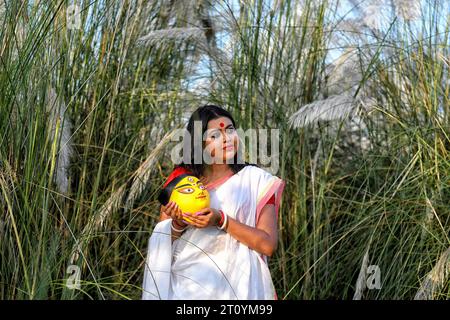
[158, 174, 209, 222]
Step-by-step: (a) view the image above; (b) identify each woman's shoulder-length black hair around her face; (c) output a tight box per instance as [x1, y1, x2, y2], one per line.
[175, 104, 257, 177]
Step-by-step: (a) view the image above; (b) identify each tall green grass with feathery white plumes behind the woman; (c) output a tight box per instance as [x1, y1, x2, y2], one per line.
[0, 0, 450, 299]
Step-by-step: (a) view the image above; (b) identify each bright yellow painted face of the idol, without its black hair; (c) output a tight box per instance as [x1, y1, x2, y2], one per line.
[169, 176, 209, 221]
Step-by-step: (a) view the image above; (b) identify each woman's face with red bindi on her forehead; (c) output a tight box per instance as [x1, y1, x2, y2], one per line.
[205, 117, 239, 163]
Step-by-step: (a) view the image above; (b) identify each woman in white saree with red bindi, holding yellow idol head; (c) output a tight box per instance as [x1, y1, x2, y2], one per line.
[142, 105, 284, 300]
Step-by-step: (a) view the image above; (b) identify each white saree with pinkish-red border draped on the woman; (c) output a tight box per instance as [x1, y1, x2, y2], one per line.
[142, 166, 285, 300]
